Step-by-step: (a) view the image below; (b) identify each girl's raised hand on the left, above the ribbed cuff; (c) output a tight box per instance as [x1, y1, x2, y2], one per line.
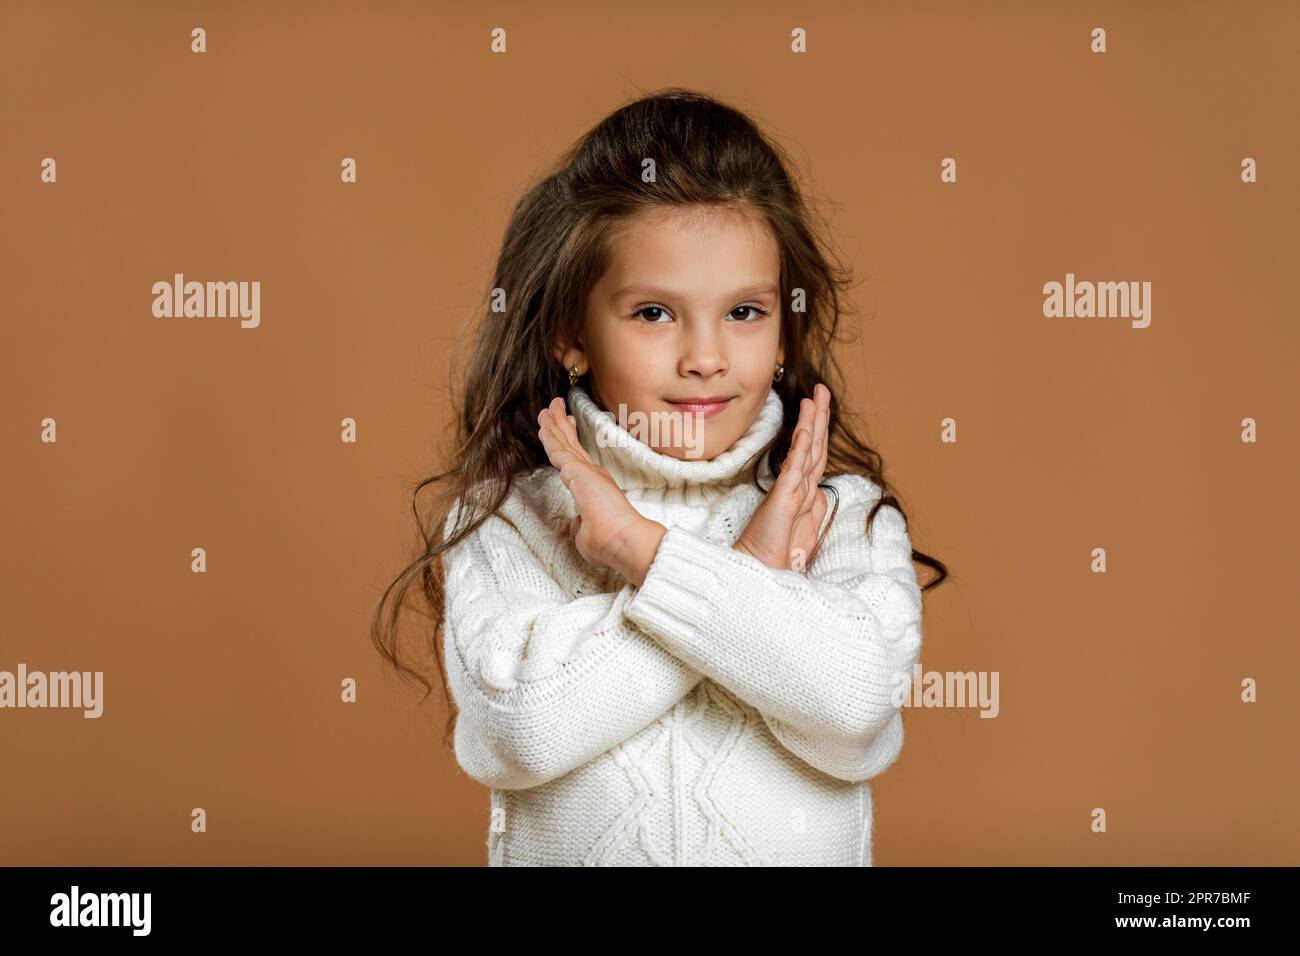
[537, 395, 658, 579]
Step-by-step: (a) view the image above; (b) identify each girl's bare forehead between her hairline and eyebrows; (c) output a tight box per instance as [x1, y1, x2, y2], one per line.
[598, 207, 780, 297]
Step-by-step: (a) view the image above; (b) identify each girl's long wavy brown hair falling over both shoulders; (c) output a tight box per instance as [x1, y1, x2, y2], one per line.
[371, 87, 948, 743]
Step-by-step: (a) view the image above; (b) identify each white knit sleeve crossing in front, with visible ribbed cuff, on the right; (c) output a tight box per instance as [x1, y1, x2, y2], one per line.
[624, 475, 922, 782]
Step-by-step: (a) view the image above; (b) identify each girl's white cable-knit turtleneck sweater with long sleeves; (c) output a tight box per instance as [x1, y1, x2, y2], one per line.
[443, 386, 920, 866]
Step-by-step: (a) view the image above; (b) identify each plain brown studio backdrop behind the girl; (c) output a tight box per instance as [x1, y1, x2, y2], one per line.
[0, 0, 1300, 866]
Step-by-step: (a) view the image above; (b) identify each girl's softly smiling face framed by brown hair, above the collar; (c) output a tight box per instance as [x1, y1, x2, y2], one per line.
[560, 207, 783, 459]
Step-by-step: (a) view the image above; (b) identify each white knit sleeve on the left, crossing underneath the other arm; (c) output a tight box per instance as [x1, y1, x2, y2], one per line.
[443, 496, 703, 790]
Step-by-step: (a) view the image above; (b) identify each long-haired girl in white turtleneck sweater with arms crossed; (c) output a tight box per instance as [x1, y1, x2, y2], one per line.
[374, 90, 948, 866]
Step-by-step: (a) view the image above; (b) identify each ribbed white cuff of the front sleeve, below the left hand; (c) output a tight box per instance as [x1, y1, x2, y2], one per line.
[623, 525, 722, 649]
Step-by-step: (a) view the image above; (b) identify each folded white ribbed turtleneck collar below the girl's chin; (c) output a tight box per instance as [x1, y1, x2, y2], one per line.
[568, 385, 784, 494]
